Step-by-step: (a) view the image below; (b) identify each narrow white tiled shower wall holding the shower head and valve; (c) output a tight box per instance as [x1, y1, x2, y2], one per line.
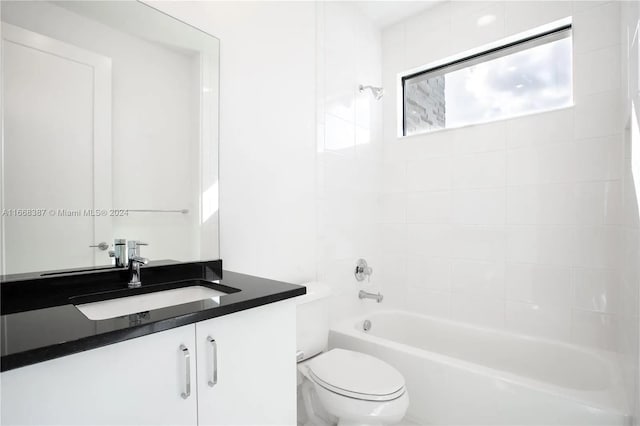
[316, 2, 384, 321]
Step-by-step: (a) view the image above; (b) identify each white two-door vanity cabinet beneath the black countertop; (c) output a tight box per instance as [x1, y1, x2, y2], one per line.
[0, 301, 296, 426]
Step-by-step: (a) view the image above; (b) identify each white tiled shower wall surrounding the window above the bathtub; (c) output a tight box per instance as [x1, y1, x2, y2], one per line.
[378, 1, 623, 350]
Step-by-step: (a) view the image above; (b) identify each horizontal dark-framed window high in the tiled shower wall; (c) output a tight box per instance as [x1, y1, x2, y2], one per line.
[402, 24, 573, 136]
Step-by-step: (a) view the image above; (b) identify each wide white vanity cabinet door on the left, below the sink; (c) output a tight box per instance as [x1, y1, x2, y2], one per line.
[0, 325, 197, 425]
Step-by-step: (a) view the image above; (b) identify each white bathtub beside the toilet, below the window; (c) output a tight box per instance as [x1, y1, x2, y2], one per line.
[329, 311, 630, 426]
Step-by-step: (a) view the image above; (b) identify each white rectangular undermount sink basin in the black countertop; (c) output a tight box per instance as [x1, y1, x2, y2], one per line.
[76, 285, 227, 320]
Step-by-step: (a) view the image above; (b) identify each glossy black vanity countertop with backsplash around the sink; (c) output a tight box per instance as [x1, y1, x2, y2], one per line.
[0, 260, 306, 371]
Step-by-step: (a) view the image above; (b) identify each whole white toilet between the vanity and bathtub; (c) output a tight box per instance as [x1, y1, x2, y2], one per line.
[297, 283, 409, 426]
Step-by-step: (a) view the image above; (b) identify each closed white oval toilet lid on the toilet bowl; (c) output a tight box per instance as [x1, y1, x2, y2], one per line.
[308, 349, 404, 401]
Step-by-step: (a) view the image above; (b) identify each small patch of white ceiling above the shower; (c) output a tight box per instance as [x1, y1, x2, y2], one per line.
[354, 0, 443, 28]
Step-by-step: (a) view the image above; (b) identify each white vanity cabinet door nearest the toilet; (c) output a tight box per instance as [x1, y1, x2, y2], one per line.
[196, 301, 296, 426]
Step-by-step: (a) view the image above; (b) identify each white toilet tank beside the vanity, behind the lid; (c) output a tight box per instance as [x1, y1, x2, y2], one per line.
[296, 282, 331, 362]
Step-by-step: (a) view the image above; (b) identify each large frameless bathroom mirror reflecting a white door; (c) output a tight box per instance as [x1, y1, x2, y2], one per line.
[0, 1, 219, 275]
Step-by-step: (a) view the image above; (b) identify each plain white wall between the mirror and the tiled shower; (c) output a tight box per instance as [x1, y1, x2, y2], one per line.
[150, 2, 316, 283]
